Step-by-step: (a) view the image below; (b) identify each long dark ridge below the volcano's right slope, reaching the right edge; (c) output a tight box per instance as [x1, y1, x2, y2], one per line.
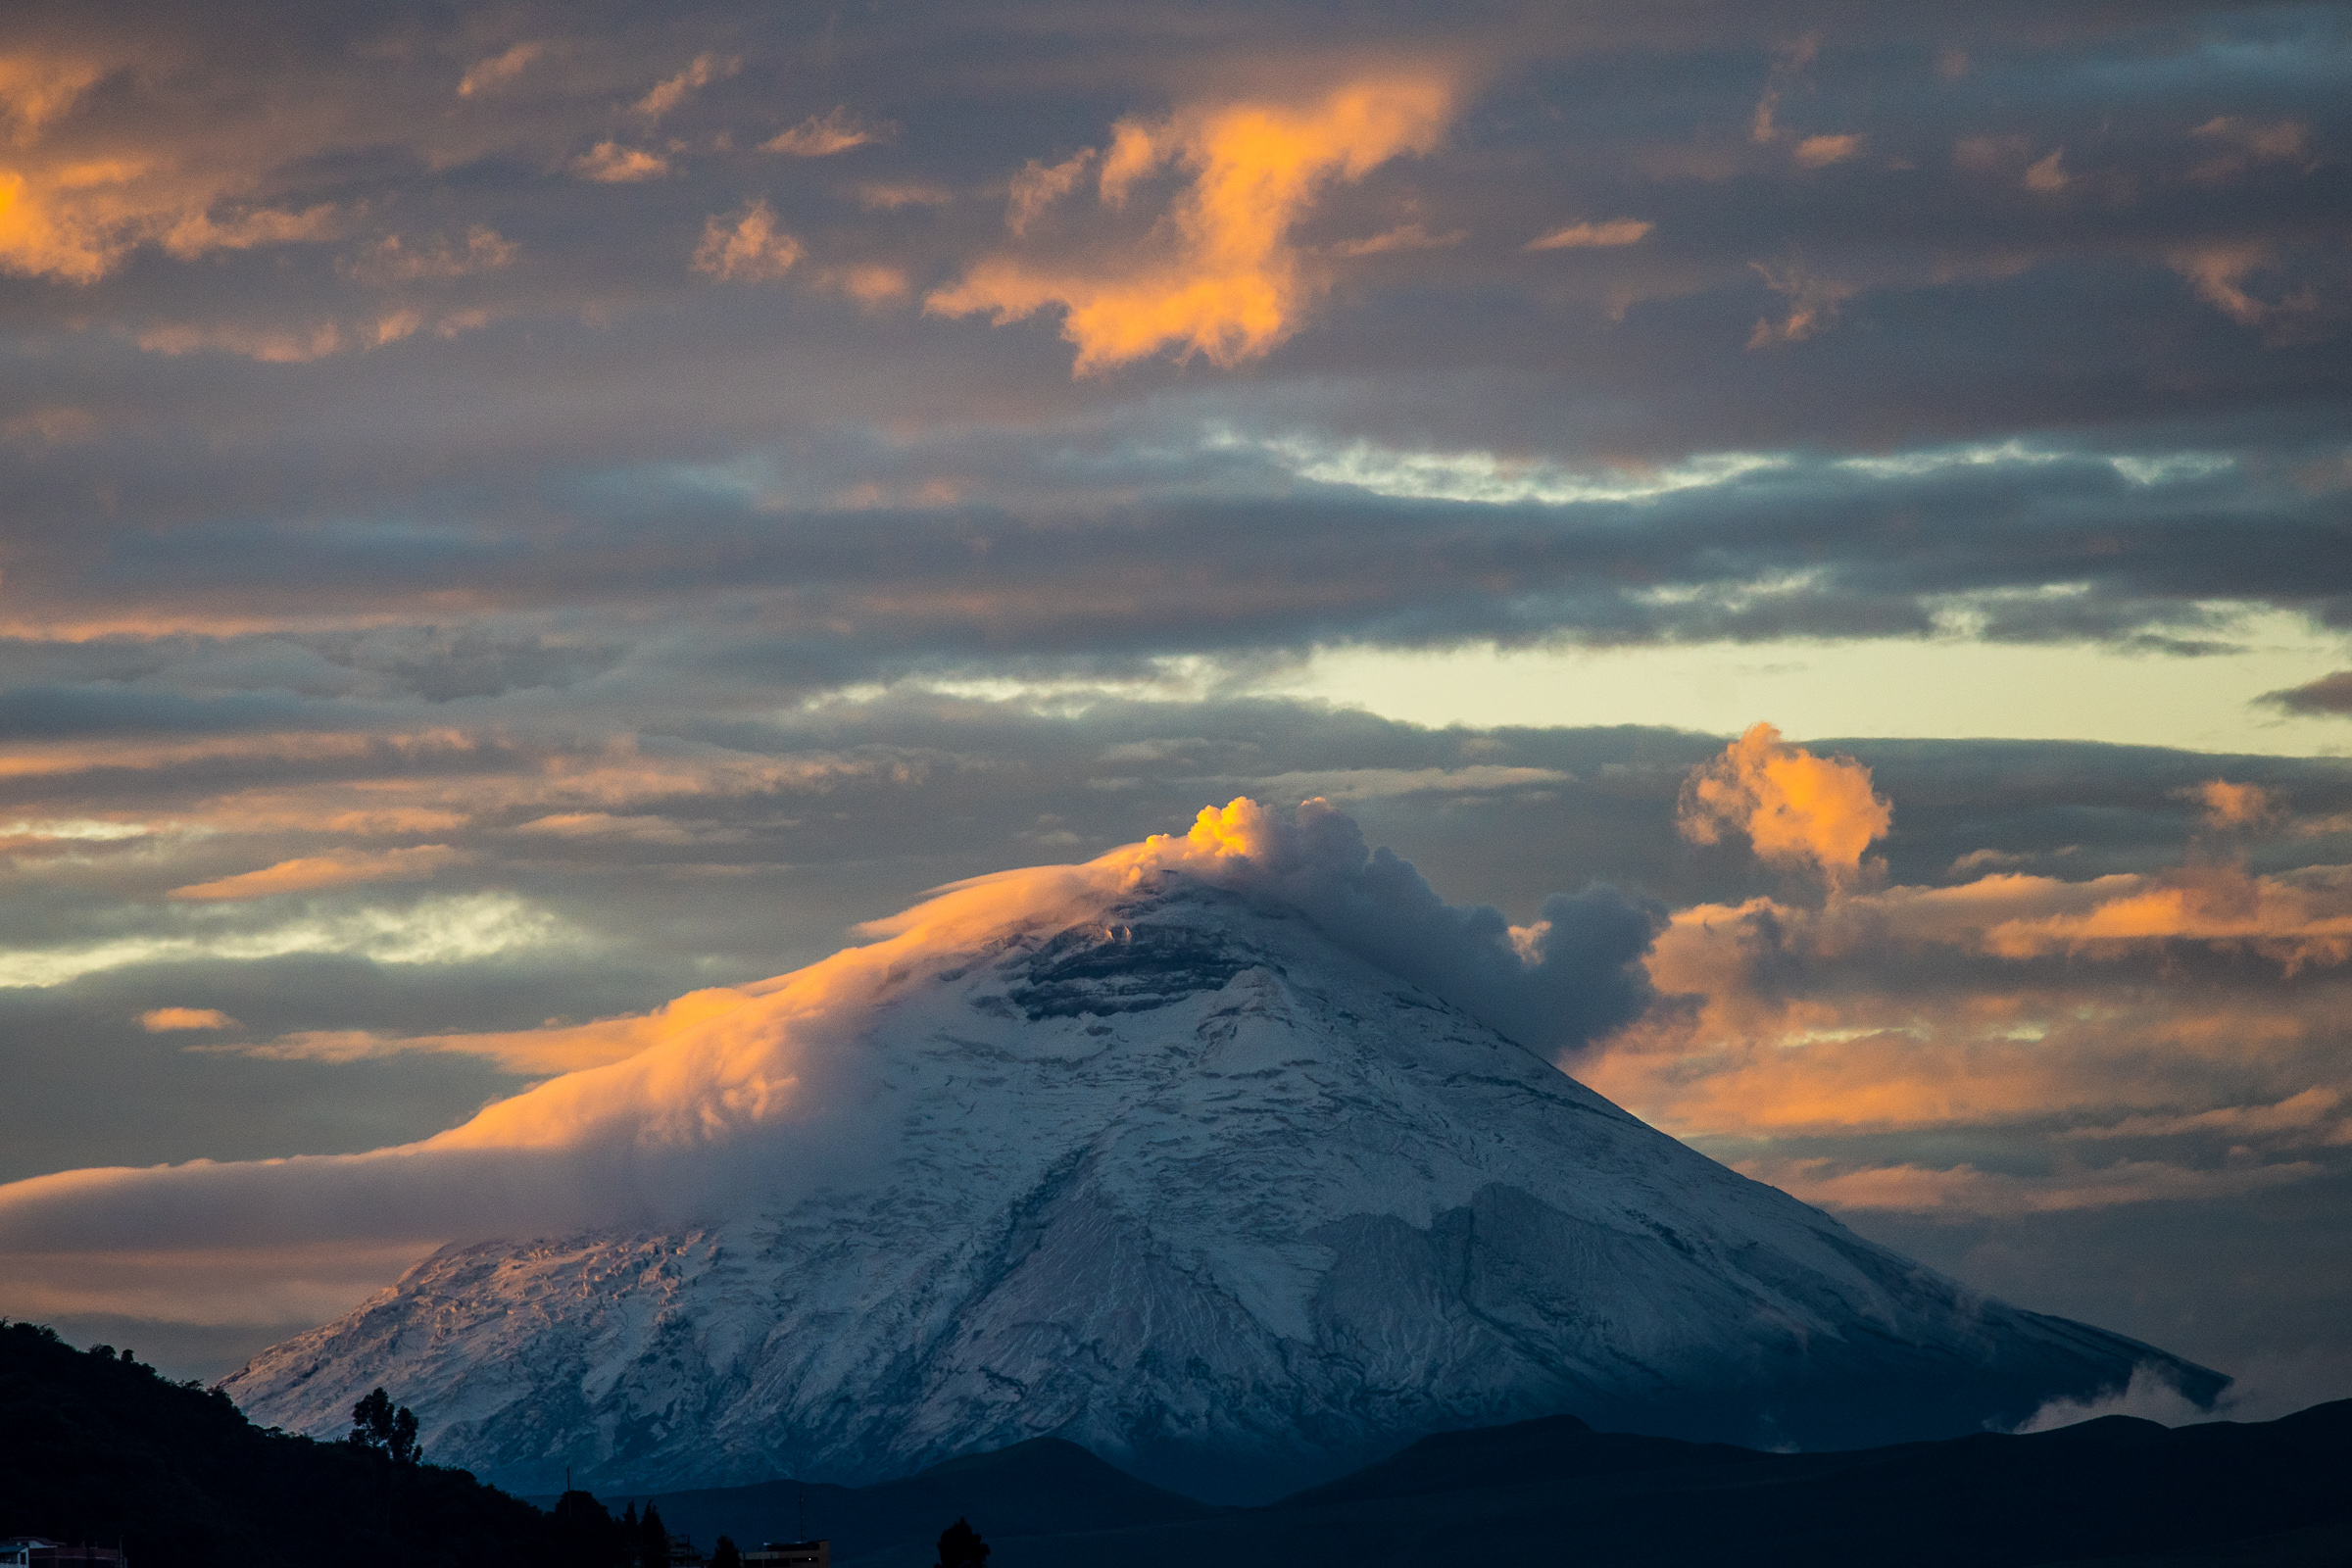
[1020, 1401, 2352, 1568]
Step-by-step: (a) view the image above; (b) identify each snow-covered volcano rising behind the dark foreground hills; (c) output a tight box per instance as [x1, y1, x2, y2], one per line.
[212, 811, 2221, 1499]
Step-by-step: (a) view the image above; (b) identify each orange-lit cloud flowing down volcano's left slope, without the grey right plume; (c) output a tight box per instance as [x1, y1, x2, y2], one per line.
[0, 800, 1627, 1277]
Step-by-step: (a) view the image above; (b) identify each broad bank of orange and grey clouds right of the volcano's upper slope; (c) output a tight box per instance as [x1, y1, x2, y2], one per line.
[1571, 841, 2352, 1213]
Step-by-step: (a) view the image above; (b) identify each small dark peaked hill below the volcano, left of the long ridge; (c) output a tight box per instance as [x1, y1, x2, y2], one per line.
[635, 1437, 1221, 1563]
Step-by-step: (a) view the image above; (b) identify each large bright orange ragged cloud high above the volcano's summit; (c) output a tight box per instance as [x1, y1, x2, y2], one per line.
[924, 75, 1453, 376]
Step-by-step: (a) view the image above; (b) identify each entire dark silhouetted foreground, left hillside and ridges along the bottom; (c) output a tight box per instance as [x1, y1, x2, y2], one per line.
[18, 1324, 2352, 1568]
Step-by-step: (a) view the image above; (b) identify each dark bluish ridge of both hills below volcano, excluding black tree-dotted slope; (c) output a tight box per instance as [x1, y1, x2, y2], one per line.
[657, 1401, 2352, 1568]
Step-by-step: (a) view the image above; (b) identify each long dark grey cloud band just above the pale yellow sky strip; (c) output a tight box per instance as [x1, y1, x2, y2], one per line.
[10, 449, 2352, 691]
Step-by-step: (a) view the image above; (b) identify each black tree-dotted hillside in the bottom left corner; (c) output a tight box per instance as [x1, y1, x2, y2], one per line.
[0, 1324, 607, 1568]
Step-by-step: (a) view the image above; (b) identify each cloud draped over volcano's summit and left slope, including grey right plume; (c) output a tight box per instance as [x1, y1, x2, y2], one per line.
[0, 797, 1653, 1312]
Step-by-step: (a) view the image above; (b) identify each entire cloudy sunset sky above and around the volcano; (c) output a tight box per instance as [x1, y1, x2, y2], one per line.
[0, 0, 2352, 1410]
